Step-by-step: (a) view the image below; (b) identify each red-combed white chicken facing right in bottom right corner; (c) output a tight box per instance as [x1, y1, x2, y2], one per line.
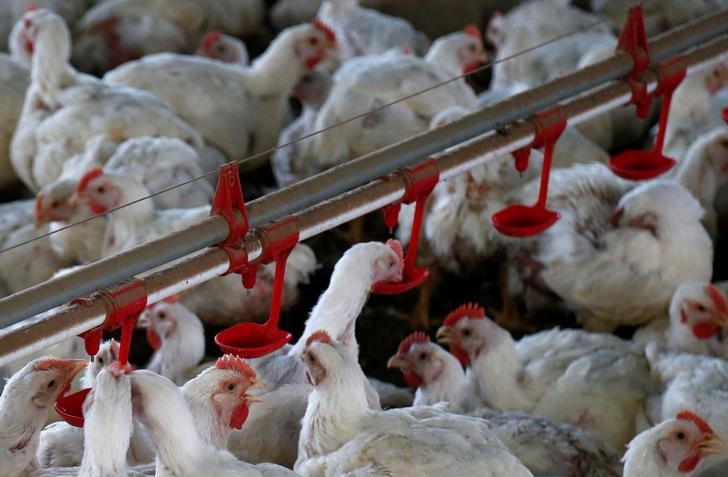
[624, 411, 725, 477]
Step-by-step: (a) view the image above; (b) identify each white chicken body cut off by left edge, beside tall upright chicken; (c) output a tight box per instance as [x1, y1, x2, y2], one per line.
[0, 54, 30, 190]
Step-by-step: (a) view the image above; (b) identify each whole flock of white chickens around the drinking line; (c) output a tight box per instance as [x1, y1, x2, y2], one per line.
[0, 0, 728, 477]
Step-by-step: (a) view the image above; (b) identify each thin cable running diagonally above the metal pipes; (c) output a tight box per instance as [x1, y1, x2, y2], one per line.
[0, 19, 607, 254]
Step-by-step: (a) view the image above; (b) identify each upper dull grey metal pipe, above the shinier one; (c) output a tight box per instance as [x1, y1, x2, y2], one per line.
[0, 10, 728, 327]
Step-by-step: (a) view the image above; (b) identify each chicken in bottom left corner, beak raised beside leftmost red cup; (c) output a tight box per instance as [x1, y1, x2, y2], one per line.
[0, 358, 86, 477]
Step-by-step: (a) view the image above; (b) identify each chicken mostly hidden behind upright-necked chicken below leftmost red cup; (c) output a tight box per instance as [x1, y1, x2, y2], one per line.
[37, 339, 155, 475]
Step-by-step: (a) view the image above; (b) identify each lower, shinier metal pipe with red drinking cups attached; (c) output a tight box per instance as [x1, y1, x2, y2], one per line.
[0, 37, 728, 365]
